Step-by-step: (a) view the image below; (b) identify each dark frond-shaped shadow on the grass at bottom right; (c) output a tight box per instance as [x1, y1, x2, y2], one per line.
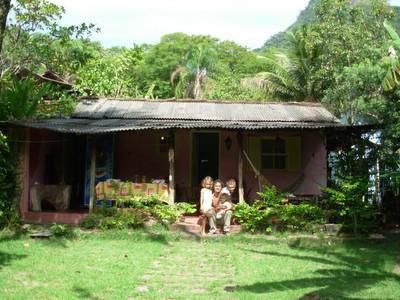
[235, 237, 400, 299]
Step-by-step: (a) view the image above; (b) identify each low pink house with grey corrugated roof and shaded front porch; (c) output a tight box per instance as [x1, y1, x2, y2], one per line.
[7, 99, 342, 223]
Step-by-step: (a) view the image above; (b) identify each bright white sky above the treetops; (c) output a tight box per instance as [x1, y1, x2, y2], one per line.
[51, 0, 400, 49]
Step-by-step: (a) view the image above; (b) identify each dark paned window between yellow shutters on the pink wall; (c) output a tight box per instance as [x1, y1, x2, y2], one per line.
[261, 137, 287, 170]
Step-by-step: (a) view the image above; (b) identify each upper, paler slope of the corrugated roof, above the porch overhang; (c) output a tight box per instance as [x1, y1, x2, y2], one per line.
[72, 99, 339, 123]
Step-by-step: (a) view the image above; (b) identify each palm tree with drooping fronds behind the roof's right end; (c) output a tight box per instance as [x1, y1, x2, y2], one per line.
[256, 26, 319, 101]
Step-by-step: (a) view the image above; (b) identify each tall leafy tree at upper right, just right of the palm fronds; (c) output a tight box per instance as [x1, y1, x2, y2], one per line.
[307, 0, 393, 91]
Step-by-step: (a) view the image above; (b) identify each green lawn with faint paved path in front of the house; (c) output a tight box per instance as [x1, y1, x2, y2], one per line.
[0, 229, 400, 299]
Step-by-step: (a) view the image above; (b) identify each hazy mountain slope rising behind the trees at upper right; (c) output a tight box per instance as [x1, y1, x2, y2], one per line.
[256, 0, 400, 52]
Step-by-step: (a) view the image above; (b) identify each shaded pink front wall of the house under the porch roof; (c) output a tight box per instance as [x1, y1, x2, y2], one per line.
[114, 130, 327, 201]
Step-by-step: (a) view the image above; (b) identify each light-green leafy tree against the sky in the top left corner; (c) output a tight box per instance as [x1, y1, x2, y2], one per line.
[0, 0, 98, 75]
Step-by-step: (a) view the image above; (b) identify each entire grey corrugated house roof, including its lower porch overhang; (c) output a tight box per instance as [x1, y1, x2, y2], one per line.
[11, 99, 342, 134]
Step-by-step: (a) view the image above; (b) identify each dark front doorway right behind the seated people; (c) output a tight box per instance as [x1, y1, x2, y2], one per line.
[192, 132, 219, 187]
